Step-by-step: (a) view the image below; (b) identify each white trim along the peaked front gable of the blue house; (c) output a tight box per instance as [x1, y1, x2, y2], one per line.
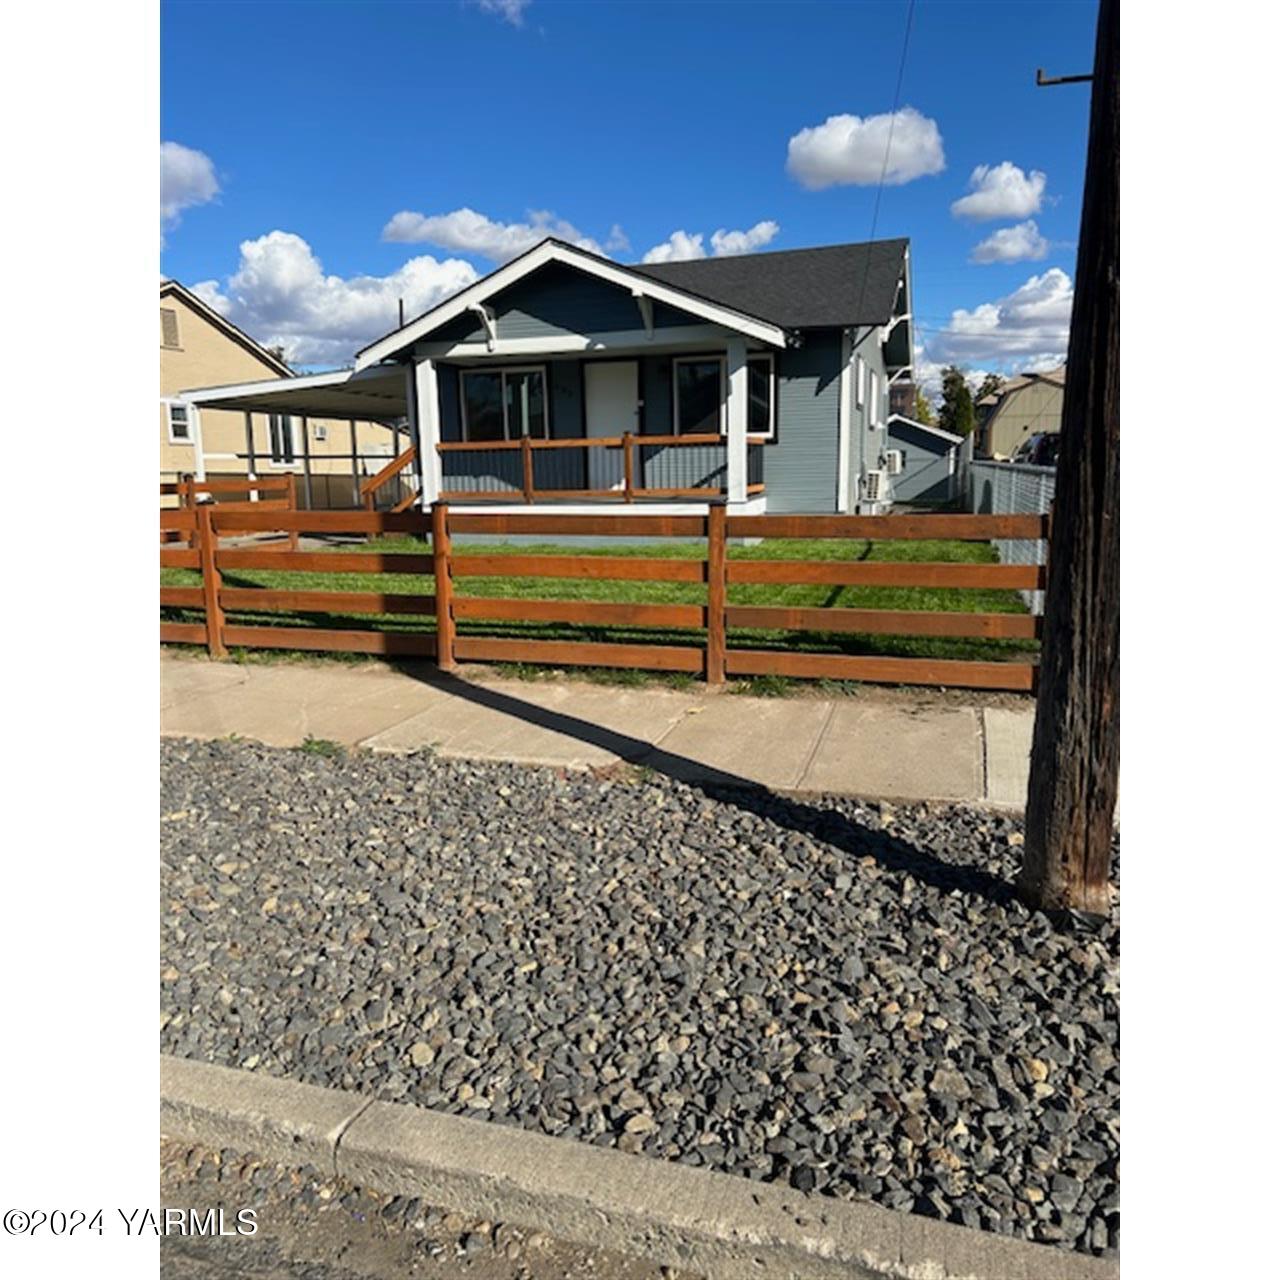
[356, 239, 786, 370]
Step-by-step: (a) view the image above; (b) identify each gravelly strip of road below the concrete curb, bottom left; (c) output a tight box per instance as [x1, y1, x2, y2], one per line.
[160, 1140, 694, 1280]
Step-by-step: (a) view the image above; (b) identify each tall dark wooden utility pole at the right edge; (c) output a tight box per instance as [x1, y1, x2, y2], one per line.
[1019, 0, 1120, 914]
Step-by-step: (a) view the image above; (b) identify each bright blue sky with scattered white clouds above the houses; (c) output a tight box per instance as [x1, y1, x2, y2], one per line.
[161, 0, 1096, 375]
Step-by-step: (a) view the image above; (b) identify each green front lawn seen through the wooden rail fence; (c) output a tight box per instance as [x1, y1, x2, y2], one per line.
[160, 538, 1037, 660]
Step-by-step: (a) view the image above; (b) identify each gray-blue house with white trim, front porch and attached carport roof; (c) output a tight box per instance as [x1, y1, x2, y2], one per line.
[187, 239, 913, 512]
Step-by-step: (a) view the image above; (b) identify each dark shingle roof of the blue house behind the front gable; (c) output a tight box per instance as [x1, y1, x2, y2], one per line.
[631, 239, 908, 329]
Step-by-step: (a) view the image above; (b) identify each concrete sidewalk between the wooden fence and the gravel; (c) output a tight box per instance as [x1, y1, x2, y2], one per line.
[160, 653, 1034, 808]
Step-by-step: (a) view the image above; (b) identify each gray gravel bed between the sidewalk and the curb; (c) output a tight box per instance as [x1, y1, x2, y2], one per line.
[161, 740, 1120, 1253]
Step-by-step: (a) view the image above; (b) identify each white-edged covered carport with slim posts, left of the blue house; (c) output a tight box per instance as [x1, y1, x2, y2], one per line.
[180, 365, 421, 507]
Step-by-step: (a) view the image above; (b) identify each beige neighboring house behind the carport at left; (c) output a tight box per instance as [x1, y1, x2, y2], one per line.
[160, 280, 412, 508]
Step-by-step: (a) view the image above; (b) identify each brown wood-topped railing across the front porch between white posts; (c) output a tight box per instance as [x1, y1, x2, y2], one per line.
[436, 433, 764, 503]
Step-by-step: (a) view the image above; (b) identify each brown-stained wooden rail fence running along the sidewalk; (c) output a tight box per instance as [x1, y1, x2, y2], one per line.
[160, 503, 1048, 691]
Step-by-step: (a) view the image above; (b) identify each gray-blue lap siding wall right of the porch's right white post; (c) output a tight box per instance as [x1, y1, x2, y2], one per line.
[763, 330, 840, 512]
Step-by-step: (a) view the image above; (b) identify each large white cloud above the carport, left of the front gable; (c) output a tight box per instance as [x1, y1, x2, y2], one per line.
[192, 230, 476, 367]
